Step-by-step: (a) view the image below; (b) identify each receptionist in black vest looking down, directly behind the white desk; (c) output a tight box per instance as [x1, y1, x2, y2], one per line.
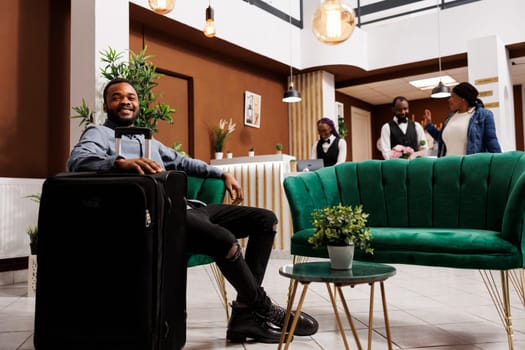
[310, 118, 346, 166]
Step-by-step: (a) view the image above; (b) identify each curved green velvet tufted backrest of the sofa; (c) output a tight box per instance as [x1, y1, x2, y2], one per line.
[284, 151, 525, 232]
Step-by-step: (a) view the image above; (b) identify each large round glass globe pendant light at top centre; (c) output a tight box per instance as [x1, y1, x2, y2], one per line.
[312, 0, 356, 45]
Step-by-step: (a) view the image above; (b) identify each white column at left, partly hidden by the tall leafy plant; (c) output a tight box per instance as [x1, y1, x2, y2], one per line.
[70, 0, 129, 147]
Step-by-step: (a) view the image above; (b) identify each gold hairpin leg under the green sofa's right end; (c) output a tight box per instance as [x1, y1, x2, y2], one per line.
[479, 270, 514, 350]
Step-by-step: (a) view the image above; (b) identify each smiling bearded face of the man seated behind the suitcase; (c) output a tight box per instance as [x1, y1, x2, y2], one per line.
[104, 83, 139, 126]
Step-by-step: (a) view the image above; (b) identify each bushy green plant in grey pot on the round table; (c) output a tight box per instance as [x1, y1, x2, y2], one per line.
[308, 204, 374, 270]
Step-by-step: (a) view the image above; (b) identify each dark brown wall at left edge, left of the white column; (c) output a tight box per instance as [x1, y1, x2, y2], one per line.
[0, 0, 70, 177]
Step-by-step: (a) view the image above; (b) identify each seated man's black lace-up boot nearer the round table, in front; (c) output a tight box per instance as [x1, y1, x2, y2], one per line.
[255, 298, 319, 336]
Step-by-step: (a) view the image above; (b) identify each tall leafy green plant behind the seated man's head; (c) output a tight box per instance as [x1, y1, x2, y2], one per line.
[72, 48, 176, 132]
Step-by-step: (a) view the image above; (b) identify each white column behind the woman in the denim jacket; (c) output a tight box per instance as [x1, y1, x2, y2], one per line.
[467, 35, 516, 151]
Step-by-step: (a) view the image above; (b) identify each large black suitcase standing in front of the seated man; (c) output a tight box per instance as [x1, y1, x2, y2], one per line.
[34, 127, 187, 350]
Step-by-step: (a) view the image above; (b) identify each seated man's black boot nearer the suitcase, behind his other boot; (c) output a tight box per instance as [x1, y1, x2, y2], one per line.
[226, 301, 281, 344]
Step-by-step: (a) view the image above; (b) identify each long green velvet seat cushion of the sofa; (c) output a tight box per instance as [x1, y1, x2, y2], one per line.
[291, 227, 520, 270]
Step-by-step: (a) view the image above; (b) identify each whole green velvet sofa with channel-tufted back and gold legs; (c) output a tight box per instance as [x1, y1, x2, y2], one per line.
[284, 151, 525, 348]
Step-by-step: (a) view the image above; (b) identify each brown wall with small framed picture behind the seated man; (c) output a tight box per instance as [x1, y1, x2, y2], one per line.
[130, 20, 288, 162]
